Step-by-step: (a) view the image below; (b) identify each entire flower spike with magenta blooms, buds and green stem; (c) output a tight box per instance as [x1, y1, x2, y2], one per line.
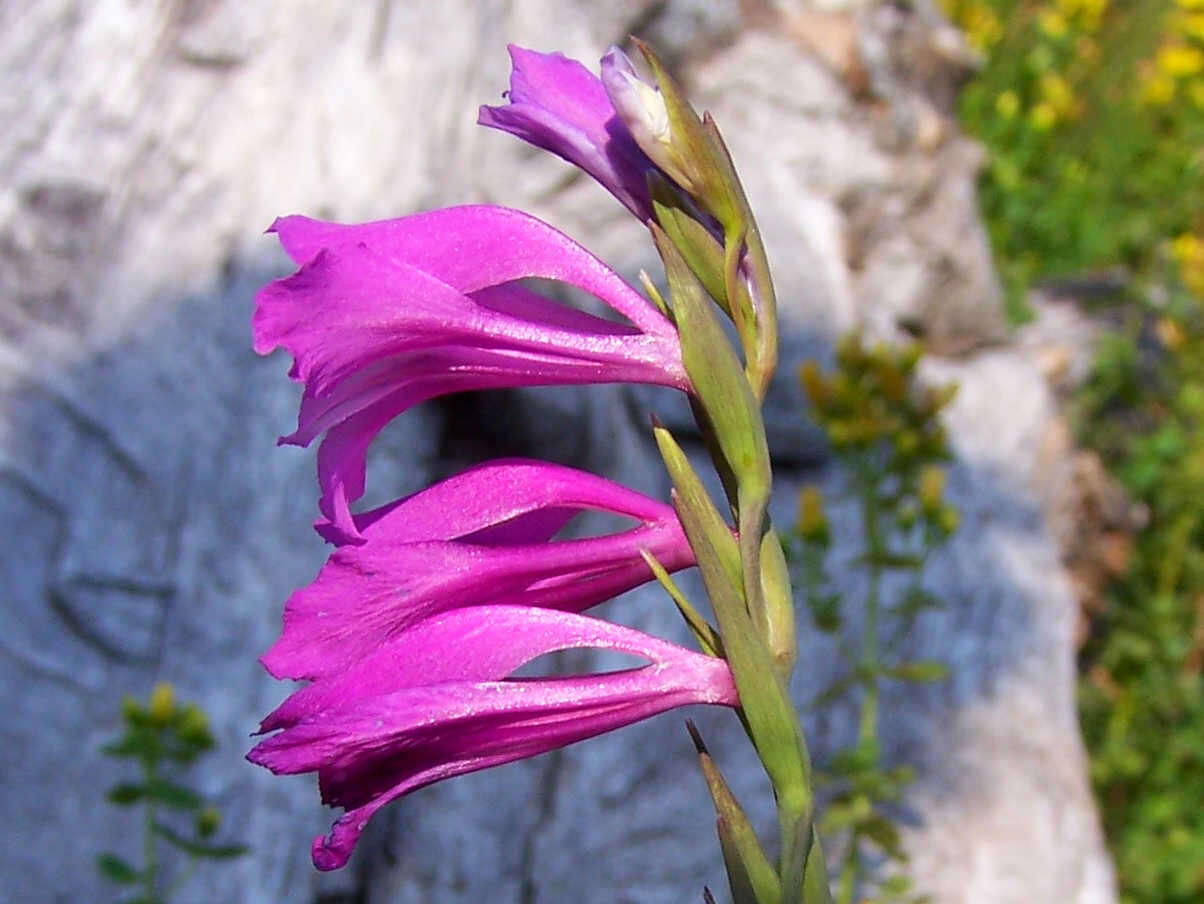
[249, 41, 830, 904]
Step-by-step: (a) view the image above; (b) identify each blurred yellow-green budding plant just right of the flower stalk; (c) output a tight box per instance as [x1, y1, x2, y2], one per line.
[789, 335, 957, 904]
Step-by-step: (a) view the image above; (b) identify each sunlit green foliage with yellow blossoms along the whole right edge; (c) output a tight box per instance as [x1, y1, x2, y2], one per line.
[943, 0, 1204, 904]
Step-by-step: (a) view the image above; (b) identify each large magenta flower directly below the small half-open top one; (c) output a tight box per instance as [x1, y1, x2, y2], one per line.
[253, 206, 690, 539]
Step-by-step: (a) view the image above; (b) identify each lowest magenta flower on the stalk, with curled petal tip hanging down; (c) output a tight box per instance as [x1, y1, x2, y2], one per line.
[248, 605, 738, 869]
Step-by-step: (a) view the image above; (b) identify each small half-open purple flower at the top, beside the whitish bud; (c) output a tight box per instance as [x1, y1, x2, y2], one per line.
[478, 45, 656, 220]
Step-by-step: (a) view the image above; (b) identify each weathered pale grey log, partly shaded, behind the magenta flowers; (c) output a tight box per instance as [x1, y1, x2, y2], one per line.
[0, 0, 1114, 904]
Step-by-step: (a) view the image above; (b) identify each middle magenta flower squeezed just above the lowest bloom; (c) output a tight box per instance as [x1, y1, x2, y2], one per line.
[261, 460, 694, 679]
